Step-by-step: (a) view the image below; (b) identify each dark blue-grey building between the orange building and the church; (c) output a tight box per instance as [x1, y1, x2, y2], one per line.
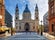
[5, 9, 12, 27]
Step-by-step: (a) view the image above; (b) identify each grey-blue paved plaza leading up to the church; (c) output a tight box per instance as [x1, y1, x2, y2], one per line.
[7, 32, 47, 40]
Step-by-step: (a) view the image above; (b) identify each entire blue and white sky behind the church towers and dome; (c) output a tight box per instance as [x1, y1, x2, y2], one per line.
[4, 0, 48, 25]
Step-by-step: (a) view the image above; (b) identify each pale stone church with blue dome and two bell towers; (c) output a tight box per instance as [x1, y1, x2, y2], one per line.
[15, 4, 39, 31]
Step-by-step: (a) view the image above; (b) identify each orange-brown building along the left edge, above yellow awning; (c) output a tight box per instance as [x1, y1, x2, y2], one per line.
[0, 0, 5, 26]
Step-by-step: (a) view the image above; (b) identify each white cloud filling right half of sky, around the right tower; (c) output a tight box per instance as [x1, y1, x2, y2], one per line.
[29, 0, 48, 23]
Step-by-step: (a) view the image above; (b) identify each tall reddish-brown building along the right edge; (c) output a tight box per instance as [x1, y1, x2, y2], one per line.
[49, 0, 55, 34]
